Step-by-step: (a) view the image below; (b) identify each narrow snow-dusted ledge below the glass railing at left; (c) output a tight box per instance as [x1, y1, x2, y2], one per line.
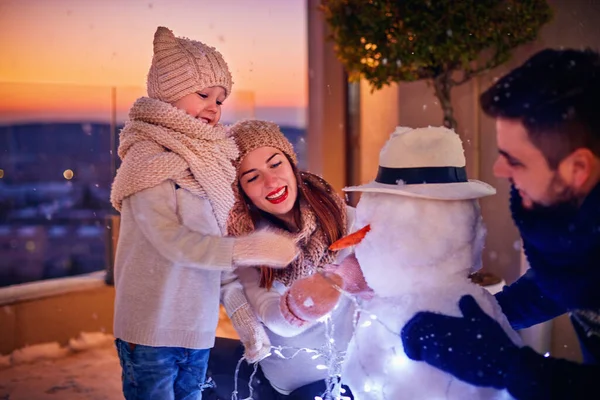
[0, 271, 106, 305]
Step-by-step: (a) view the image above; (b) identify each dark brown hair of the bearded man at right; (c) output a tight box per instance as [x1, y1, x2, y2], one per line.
[480, 49, 600, 169]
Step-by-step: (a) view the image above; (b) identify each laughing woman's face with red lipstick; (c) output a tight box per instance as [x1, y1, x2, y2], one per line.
[238, 147, 298, 220]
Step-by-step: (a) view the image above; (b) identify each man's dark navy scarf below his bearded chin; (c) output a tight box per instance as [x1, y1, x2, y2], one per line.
[511, 184, 600, 312]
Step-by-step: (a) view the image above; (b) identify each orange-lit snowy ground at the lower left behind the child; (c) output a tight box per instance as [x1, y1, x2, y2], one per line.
[0, 309, 238, 400]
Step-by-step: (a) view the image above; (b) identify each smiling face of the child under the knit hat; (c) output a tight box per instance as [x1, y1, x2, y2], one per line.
[173, 86, 225, 126]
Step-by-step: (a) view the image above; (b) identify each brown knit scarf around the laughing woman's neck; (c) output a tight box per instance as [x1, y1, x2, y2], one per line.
[227, 172, 347, 286]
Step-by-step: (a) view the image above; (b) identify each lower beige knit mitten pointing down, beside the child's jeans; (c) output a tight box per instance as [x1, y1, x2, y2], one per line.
[230, 303, 271, 364]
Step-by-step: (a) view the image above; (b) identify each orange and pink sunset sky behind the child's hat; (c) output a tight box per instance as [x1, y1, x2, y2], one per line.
[0, 0, 308, 126]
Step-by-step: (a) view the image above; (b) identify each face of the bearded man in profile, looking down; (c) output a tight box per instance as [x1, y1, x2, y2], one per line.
[494, 118, 574, 209]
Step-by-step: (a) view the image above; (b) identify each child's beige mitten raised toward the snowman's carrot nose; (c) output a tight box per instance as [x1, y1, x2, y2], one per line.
[233, 229, 300, 268]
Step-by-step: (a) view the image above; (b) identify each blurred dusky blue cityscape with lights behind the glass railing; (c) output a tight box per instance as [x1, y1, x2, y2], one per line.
[0, 83, 306, 287]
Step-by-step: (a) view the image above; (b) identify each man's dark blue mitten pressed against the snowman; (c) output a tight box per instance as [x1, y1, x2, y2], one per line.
[400, 295, 519, 389]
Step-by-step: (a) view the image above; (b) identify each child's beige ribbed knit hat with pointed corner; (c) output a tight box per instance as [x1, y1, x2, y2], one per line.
[147, 26, 233, 103]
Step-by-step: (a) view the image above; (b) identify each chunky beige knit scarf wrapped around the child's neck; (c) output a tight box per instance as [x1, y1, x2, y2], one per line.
[110, 97, 238, 234]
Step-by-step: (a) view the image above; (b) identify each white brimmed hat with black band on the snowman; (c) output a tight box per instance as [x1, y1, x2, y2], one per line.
[343, 126, 496, 200]
